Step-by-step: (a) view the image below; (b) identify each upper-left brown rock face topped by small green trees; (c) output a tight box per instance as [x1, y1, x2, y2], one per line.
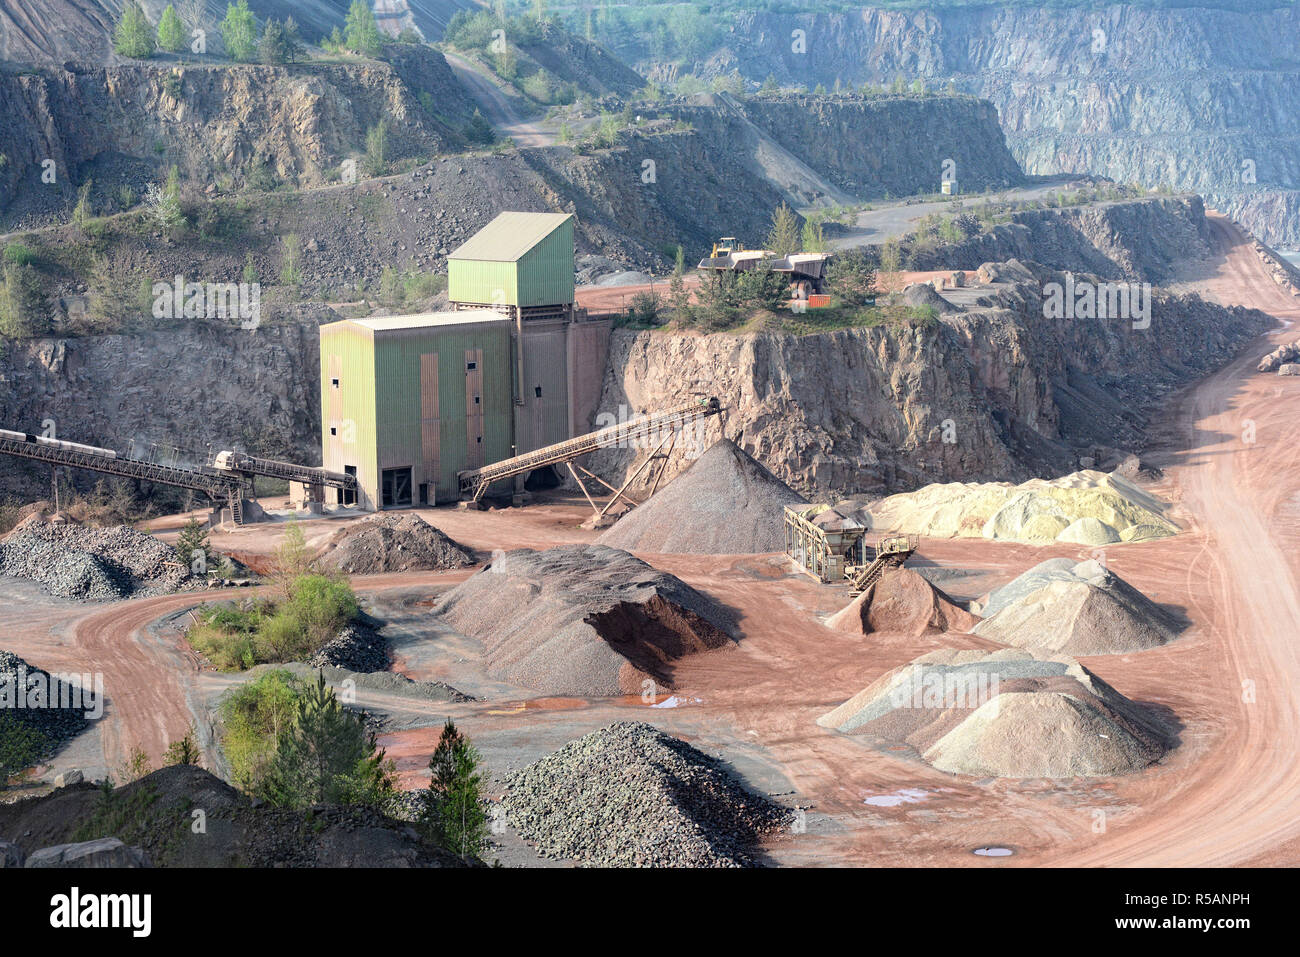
[0, 47, 473, 226]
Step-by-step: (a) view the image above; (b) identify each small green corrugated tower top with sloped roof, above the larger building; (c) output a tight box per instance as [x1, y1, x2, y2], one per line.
[447, 212, 573, 308]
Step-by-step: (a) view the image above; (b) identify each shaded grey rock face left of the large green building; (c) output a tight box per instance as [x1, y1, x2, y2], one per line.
[0, 309, 323, 499]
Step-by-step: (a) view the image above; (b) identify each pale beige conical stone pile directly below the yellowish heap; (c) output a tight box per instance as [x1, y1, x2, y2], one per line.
[975, 558, 1182, 655]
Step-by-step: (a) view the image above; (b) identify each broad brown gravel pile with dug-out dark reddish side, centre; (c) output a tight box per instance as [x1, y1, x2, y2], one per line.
[436, 545, 731, 696]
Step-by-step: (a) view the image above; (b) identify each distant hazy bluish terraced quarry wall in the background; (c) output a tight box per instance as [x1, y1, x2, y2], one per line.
[696, 4, 1300, 244]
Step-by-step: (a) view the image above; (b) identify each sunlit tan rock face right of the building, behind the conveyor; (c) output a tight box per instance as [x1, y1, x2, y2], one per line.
[598, 263, 1273, 498]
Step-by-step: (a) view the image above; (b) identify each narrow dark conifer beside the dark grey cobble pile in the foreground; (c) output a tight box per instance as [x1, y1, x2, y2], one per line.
[421, 718, 488, 858]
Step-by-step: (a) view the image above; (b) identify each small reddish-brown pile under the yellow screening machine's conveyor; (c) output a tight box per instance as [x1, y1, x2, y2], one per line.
[827, 567, 979, 636]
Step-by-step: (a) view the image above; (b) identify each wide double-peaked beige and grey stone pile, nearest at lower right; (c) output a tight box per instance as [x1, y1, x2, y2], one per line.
[818, 648, 1174, 778]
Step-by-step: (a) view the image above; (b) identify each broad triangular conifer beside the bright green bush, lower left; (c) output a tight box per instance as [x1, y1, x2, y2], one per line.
[260, 672, 397, 807]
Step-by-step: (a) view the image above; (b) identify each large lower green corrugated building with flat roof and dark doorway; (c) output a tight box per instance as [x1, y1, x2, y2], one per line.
[320, 309, 514, 510]
